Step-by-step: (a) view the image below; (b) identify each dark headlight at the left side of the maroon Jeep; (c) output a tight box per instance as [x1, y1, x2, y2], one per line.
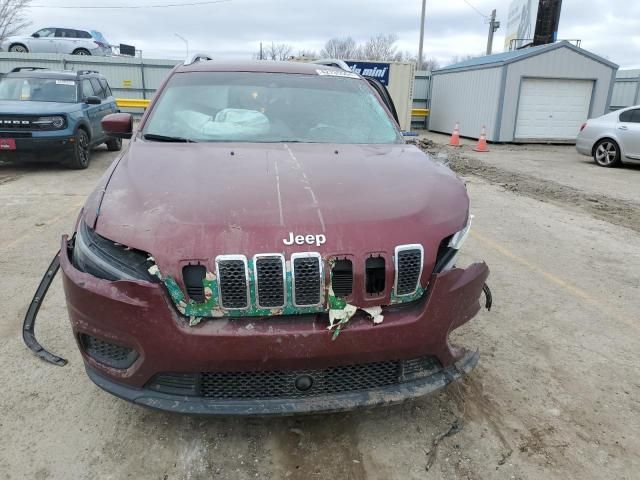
[72, 221, 157, 282]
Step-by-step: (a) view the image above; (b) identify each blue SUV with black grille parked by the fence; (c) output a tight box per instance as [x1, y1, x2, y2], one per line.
[0, 67, 122, 168]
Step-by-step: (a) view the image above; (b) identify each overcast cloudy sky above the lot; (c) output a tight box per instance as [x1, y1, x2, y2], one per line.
[25, 0, 640, 68]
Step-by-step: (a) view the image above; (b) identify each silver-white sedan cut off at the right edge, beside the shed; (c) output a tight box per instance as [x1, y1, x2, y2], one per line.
[576, 105, 640, 167]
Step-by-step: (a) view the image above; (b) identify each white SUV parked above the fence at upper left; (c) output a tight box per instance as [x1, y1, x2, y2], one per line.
[0, 27, 112, 56]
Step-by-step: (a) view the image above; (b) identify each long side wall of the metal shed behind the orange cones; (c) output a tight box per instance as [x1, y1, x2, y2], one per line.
[429, 67, 504, 141]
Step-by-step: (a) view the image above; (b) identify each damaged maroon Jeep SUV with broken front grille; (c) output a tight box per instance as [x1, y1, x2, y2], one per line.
[59, 56, 489, 415]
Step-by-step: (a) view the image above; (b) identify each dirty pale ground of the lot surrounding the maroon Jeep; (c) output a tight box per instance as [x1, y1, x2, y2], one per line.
[0, 135, 640, 480]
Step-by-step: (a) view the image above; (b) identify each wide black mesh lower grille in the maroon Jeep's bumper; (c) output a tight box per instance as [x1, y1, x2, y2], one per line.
[147, 357, 440, 400]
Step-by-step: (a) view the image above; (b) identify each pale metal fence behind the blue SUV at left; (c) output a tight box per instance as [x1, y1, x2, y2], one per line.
[0, 52, 180, 98]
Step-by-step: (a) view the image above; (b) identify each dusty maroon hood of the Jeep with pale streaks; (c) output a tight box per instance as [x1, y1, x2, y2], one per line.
[90, 139, 468, 276]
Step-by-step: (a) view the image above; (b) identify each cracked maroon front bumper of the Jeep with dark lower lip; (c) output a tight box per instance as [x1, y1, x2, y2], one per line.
[60, 234, 489, 415]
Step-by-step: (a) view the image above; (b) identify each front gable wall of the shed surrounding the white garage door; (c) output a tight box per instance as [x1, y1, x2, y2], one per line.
[500, 48, 614, 142]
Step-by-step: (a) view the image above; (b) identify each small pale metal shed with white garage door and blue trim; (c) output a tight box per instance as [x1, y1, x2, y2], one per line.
[429, 41, 618, 142]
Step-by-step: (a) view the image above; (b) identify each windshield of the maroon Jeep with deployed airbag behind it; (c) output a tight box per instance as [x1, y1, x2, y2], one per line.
[143, 72, 402, 144]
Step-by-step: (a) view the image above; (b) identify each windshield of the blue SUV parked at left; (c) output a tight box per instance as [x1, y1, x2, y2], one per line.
[0, 77, 78, 103]
